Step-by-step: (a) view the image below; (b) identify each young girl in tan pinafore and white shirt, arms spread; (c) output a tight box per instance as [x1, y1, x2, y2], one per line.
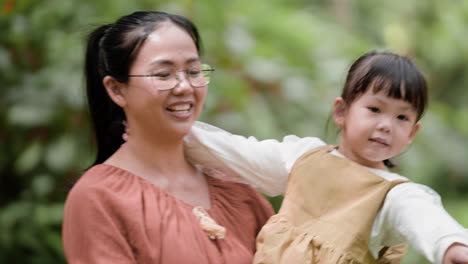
[186, 52, 468, 263]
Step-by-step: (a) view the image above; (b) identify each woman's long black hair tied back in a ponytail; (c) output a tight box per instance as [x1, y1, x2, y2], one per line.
[85, 11, 201, 164]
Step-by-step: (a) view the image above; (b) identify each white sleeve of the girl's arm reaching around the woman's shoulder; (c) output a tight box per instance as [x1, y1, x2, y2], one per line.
[185, 122, 325, 196]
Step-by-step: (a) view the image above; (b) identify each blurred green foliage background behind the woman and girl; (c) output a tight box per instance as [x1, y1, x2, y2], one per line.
[0, 0, 468, 263]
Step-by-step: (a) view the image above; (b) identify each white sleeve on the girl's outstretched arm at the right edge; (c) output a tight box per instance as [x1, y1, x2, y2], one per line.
[374, 183, 468, 263]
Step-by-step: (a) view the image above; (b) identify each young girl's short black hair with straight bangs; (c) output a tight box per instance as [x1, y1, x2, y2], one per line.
[341, 51, 428, 168]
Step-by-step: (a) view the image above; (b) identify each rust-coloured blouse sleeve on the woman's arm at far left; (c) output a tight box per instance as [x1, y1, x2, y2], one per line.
[62, 185, 136, 264]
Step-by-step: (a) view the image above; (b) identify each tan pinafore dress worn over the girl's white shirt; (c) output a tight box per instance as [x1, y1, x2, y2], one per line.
[254, 146, 406, 264]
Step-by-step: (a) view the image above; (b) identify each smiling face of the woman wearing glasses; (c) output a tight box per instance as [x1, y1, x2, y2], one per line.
[123, 22, 207, 139]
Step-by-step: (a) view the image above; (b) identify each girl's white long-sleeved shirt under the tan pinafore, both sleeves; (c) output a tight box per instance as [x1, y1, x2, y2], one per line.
[185, 122, 468, 263]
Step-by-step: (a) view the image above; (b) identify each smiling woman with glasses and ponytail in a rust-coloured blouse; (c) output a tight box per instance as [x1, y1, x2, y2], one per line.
[63, 12, 273, 264]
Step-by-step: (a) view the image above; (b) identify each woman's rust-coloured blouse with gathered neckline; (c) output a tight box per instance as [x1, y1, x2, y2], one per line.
[63, 164, 273, 264]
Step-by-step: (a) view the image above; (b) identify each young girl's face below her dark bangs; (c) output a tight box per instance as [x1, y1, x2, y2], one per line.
[333, 88, 420, 169]
